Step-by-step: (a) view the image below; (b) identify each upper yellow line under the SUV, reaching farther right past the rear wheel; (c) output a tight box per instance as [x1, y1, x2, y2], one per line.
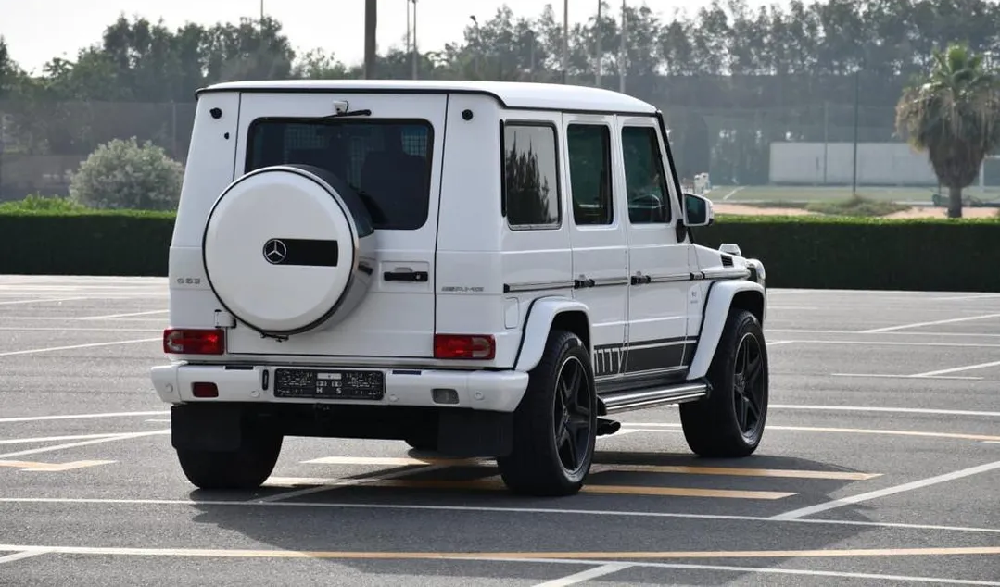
[302, 456, 882, 481]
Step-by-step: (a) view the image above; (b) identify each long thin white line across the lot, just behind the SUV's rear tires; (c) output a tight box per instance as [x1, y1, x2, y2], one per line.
[0, 497, 1000, 536]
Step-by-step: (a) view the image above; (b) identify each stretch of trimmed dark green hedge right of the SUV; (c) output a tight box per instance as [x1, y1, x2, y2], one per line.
[695, 216, 1000, 292]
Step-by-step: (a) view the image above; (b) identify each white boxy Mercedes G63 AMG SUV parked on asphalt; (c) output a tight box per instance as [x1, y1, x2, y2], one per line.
[152, 81, 768, 495]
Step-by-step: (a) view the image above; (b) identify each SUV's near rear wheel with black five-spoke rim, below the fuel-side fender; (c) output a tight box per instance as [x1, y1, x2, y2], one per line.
[497, 331, 597, 496]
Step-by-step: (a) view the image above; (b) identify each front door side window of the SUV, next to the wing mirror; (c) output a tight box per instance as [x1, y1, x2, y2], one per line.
[622, 126, 671, 224]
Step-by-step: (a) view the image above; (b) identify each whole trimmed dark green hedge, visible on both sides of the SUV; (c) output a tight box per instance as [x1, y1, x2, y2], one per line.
[0, 209, 1000, 292]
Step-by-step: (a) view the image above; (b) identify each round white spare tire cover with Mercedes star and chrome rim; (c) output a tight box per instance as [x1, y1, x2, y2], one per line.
[202, 165, 375, 336]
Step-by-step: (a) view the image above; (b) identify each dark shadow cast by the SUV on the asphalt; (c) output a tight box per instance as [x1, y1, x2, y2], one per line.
[184, 451, 871, 584]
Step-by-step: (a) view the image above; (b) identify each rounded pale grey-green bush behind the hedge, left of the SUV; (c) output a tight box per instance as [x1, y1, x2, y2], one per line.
[69, 137, 184, 210]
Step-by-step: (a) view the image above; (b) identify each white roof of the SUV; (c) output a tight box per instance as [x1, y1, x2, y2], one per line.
[198, 80, 657, 114]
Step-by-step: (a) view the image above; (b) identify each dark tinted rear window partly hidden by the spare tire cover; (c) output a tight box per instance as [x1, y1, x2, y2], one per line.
[246, 118, 434, 230]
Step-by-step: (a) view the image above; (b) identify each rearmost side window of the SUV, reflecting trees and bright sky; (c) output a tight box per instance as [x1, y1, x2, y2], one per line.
[502, 123, 562, 229]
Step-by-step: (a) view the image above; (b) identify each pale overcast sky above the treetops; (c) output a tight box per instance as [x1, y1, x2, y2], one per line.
[0, 0, 772, 74]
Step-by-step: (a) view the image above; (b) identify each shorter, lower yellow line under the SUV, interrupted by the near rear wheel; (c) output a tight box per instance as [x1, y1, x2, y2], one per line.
[266, 477, 795, 499]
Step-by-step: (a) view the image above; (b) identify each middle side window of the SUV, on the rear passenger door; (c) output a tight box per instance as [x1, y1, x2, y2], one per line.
[566, 124, 615, 225]
